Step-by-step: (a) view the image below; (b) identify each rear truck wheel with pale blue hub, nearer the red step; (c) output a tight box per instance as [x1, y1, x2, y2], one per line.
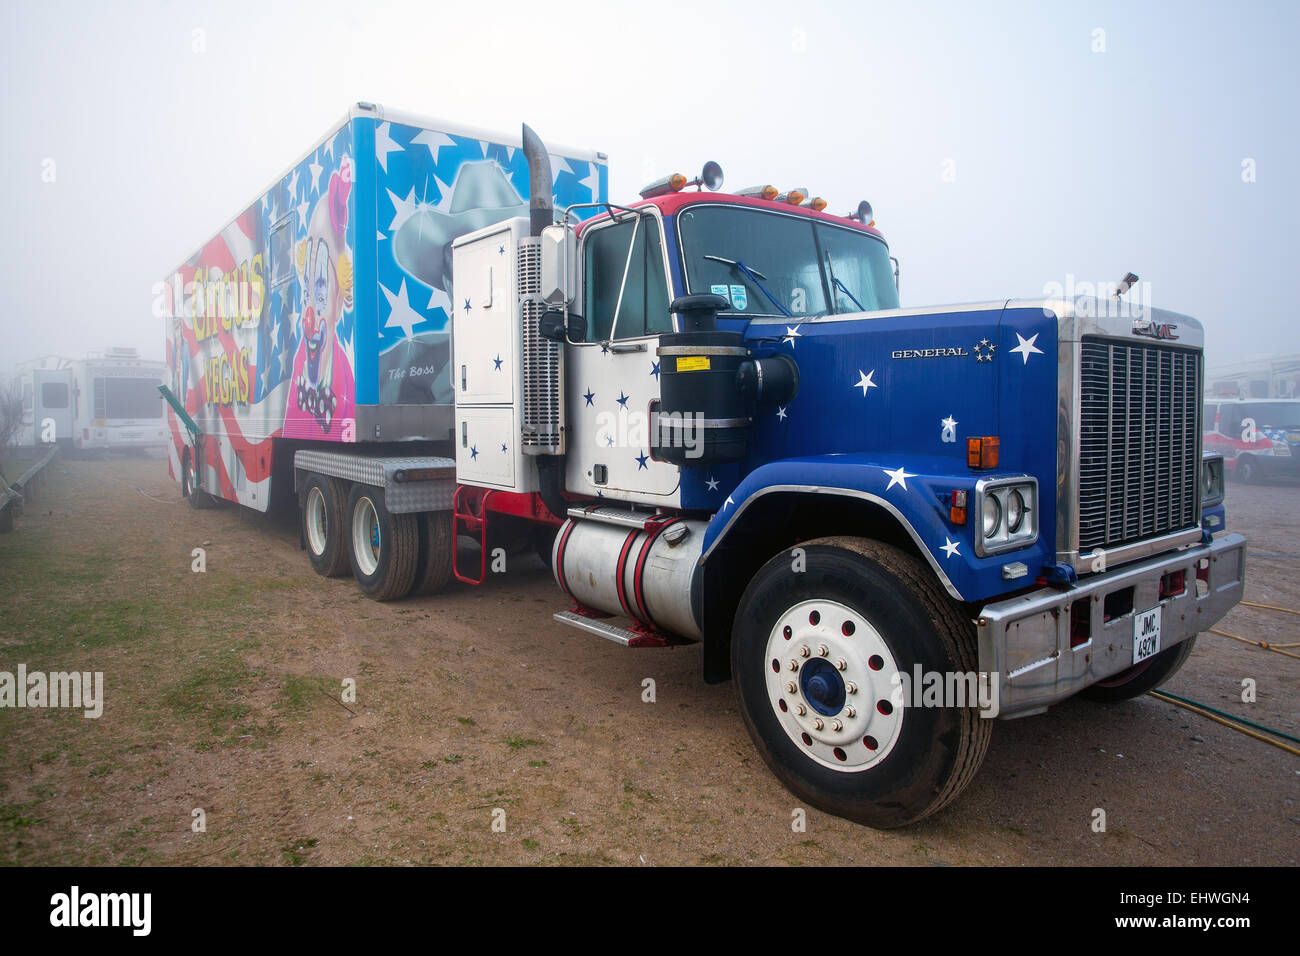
[347, 484, 420, 601]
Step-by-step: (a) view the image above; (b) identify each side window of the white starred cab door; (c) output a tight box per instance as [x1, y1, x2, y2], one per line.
[584, 216, 672, 342]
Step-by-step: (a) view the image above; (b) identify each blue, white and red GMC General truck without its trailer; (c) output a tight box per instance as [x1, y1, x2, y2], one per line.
[167, 102, 1245, 827]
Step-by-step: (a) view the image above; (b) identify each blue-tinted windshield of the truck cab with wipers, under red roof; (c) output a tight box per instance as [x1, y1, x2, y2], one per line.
[677, 204, 898, 316]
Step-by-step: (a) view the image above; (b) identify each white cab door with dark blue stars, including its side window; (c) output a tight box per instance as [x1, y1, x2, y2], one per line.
[566, 209, 680, 505]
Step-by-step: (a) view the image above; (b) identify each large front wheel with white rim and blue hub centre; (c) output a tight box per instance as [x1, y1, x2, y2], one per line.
[732, 537, 992, 827]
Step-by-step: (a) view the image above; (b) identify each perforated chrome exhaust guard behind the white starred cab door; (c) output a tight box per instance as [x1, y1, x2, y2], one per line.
[517, 237, 563, 455]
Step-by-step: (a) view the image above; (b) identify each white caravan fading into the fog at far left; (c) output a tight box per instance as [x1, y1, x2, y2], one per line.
[16, 347, 168, 453]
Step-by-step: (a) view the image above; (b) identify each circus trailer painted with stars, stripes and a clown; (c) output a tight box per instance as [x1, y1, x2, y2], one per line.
[157, 103, 608, 511]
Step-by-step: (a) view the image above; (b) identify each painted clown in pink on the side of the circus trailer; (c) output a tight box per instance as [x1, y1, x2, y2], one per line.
[291, 156, 354, 436]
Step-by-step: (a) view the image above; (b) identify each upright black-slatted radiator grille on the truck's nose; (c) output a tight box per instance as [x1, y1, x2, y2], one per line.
[1079, 337, 1201, 553]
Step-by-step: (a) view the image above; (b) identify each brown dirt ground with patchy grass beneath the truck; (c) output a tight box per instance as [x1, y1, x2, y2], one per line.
[0, 459, 1300, 866]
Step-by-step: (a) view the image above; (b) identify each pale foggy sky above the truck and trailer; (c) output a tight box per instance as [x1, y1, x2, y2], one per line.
[0, 0, 1300, 375]
